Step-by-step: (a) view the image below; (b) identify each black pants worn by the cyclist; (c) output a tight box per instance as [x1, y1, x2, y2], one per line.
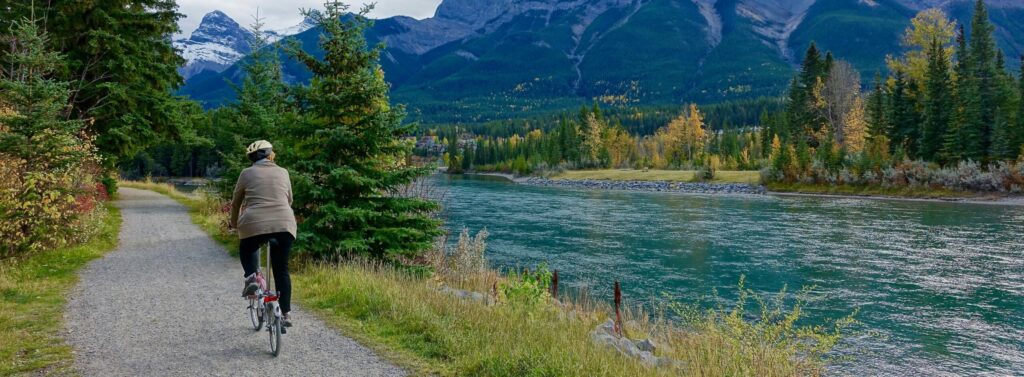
[239, 232, 295, 313]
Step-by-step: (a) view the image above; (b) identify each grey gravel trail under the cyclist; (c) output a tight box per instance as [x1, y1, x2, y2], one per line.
[65, 189, 407, 376]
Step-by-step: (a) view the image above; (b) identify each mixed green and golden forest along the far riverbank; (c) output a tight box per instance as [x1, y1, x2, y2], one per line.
[420, 1, 1024, 193]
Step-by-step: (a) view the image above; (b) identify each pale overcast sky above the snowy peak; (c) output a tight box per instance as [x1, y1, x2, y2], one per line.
[178, 0, 441, 36]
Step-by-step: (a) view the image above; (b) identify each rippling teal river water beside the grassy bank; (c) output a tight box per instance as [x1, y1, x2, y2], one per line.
[432, 176, 1024, 376]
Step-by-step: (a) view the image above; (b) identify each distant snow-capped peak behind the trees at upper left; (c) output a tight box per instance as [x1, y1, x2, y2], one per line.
[174, 10, 314, 79]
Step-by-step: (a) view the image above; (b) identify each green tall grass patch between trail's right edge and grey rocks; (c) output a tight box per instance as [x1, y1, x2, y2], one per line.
[296, 263, 674, 376]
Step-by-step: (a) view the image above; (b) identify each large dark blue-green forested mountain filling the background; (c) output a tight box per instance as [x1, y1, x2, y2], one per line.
[182, 0, 1024, 122]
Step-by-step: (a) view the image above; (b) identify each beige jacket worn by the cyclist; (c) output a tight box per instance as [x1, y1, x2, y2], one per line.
[230, 160, 296, 239]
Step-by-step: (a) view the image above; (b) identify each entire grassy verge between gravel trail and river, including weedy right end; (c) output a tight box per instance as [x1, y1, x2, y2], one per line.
[130, 182, 852, 377]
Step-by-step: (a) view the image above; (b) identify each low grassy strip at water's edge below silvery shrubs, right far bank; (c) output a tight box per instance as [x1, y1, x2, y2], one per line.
[768, 182, 975, 199]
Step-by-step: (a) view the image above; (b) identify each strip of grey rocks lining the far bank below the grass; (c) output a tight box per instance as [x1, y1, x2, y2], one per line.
[516, 177, 768, 195]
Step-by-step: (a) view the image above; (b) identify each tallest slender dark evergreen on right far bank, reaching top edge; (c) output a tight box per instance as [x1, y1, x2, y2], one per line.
[969, 0, 998, 159]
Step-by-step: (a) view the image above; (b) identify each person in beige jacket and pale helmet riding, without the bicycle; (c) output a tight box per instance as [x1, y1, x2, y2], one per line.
[228, 140, 296, 327]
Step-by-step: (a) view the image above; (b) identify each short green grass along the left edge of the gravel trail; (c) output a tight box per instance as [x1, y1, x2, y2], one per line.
[0, 203, 121, 376]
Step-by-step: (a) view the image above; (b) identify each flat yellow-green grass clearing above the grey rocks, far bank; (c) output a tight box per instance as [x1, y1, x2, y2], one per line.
[551, 169, 761, 184]
